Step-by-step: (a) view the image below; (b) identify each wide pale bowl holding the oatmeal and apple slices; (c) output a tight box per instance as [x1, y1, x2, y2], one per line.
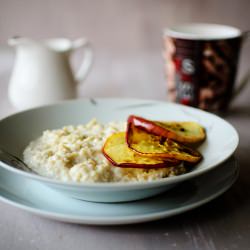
[0, 98, 239, 202]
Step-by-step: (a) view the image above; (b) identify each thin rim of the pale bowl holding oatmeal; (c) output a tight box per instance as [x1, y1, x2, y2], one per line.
[0, 97, 239, 189]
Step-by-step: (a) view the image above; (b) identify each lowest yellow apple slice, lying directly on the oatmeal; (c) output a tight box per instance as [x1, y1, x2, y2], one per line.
[102, 132, 181, 168]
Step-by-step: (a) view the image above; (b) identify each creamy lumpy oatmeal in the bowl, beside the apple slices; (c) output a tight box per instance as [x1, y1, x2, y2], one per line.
[23, 119, 185, 183]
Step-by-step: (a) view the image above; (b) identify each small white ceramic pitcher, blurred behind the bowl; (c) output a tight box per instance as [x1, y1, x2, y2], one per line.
[8, 37, 93, 109]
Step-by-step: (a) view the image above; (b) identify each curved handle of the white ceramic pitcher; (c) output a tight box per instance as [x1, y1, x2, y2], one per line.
[72, 38, 93, 83]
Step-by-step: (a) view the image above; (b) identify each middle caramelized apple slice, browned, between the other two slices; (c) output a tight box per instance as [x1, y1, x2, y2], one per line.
[126, 122, 202, 163]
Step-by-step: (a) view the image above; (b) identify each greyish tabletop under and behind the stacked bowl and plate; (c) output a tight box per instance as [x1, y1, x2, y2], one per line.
[0, 46, 250, 250]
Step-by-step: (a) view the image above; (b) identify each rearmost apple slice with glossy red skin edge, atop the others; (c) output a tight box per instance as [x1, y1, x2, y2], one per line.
[128, 115, 206, 144]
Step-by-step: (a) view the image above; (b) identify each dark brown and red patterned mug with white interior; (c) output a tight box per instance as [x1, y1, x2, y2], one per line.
[164, 23, 250, 112]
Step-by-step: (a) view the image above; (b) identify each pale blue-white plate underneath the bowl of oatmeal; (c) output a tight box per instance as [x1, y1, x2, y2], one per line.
[0, 159, 238, 225]
